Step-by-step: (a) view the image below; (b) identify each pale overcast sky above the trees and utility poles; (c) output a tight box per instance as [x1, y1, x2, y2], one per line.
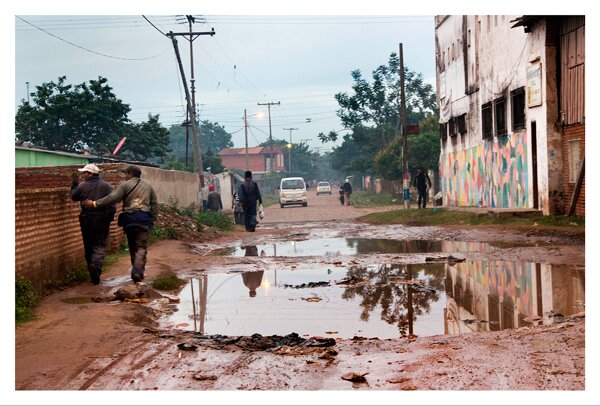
[15, 10, 435, 152]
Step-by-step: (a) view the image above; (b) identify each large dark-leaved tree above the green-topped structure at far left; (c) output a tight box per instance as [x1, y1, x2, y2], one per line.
[15, 76, 131, 153]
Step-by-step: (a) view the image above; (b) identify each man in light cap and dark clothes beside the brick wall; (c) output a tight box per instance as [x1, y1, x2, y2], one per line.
[71, 164, 116, 285]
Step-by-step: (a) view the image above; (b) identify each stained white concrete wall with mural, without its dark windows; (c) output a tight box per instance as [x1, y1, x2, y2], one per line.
[436, 16, 562, 214]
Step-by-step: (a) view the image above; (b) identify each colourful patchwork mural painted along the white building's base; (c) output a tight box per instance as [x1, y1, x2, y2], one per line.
[440, 131, 529, 208]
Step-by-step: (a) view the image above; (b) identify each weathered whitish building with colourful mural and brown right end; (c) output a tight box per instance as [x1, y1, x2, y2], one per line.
[435, 15, 585, 215]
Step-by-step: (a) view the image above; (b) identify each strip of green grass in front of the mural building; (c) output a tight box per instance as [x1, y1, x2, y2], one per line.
[360, 208, 585, 229]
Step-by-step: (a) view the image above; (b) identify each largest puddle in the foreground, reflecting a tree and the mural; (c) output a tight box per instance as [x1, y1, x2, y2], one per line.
[162, 260, 585, 339]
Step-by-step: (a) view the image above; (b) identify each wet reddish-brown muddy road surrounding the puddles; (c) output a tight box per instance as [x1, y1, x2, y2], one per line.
[15, 196, 593, 403]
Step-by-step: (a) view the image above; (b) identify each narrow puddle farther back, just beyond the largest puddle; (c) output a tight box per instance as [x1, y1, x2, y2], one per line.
[214, 238, 530, 257]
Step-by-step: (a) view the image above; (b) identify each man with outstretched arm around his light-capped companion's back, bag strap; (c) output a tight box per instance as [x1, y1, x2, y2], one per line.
[84, 165, 158, 282]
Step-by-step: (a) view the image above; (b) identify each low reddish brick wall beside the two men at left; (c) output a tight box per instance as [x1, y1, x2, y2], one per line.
[15, 164, 130, 289]
